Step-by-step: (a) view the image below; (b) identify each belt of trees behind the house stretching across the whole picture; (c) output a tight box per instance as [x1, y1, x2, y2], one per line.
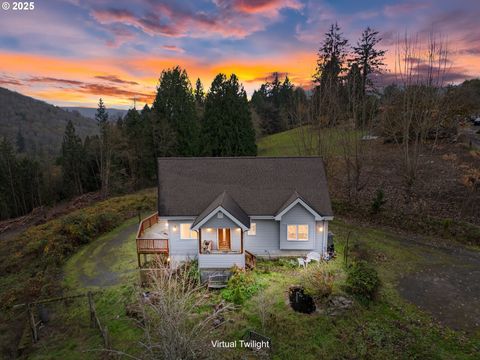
[0, 24, 480, 219]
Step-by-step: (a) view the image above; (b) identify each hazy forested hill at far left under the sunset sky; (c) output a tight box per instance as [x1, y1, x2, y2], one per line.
[0, 88, 98, 159]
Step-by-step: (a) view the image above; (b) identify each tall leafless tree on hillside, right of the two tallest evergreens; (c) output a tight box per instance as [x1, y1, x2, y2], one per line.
[381, 34, 448, 202]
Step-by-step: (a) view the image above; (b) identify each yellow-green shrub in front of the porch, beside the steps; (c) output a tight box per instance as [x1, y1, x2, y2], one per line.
[222, 268, 261, 305]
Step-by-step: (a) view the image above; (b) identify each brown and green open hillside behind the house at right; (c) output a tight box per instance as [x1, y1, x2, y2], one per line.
[257, 126, 480, 236]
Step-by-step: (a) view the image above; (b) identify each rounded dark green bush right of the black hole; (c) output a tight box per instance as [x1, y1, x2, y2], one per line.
[346, 261, 380, 300]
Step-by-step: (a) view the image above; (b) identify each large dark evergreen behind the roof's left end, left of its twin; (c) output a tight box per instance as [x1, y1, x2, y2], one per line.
[153, 66, 199, 156]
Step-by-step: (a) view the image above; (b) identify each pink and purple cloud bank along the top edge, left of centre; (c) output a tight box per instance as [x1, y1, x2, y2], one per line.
[90, 0, 303, 38]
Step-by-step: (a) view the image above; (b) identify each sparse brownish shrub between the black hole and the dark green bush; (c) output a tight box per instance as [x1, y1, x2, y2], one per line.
[302, 265, 335, 300]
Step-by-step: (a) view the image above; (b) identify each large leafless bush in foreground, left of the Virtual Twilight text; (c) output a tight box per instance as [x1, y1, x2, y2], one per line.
[131, 264, 230, 359]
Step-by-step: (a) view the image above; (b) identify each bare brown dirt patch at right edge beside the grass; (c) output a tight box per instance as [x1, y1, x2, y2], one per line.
[398, 242, 480, 332]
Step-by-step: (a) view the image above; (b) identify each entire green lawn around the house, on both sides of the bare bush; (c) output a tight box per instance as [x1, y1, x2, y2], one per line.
[26, 215, 480, 359]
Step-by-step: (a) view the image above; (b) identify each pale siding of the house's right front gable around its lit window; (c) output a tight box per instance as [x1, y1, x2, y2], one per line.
[280, 204, 316, 250]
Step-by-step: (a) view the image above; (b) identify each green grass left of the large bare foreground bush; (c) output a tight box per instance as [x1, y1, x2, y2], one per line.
[29, 217, 141, 359]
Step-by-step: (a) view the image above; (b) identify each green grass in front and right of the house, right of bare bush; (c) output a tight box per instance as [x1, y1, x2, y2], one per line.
[219, 221, 480, 359]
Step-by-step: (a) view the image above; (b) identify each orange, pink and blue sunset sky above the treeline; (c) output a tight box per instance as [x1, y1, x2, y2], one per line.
[0, 0, 480, 108]
